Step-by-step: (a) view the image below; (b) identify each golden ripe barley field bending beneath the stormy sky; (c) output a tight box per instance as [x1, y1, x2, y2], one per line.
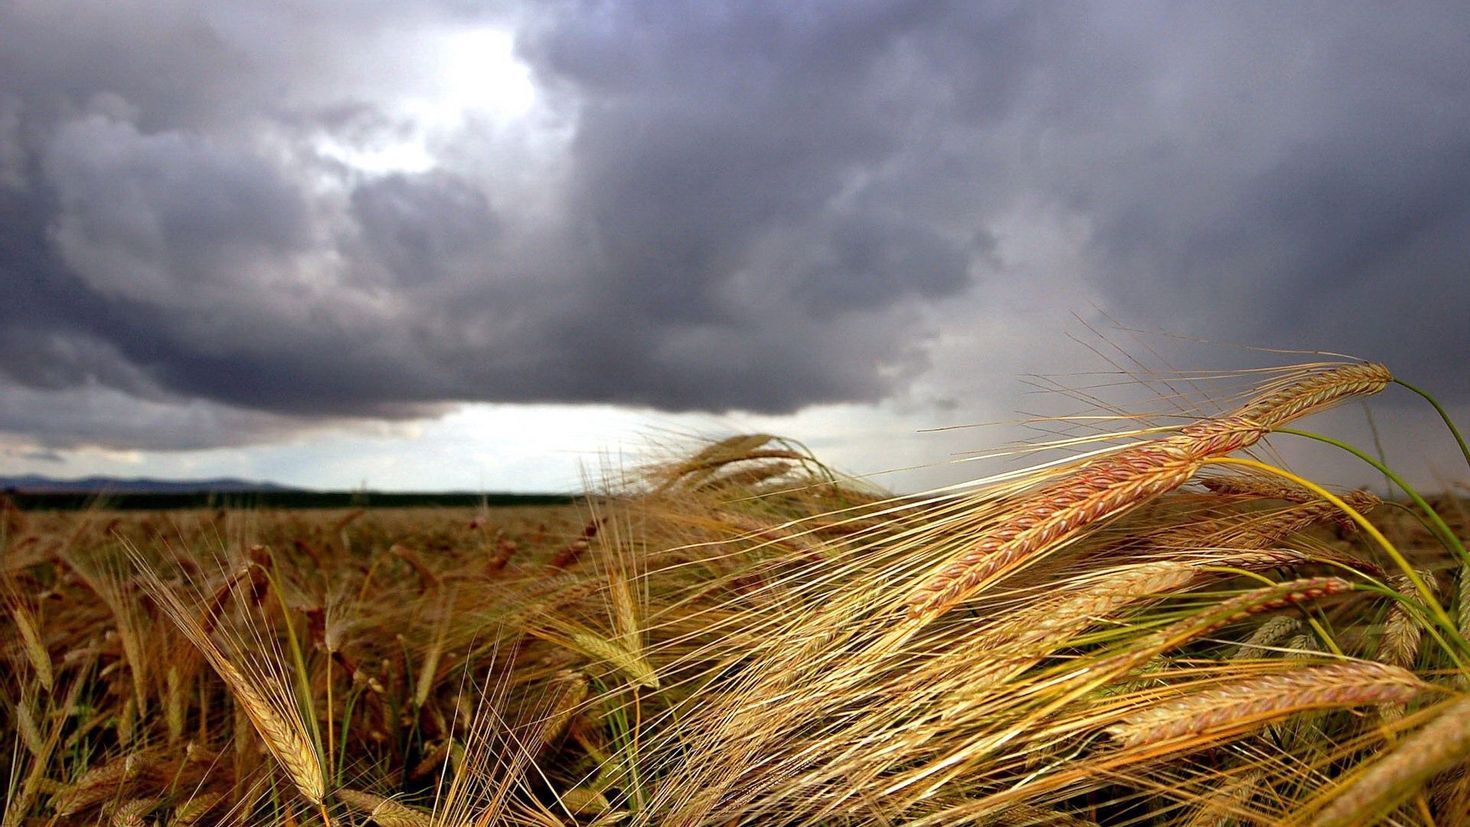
[0, 363, 1470, 827]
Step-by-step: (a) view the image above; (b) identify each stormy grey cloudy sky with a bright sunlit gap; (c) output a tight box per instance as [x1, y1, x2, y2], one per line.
[0, 0, 1470, 491]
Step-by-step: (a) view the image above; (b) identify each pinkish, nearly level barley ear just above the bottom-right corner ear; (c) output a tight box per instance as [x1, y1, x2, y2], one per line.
[1105, 661, 1427, 748]
